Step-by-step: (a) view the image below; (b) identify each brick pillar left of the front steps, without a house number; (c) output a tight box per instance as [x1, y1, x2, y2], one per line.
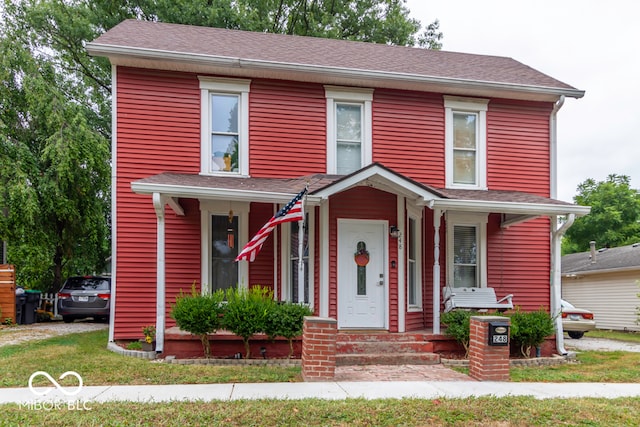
[302, 317, 338, 381]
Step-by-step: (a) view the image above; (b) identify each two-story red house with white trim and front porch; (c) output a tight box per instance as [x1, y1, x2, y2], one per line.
[87, 20, 589, 351]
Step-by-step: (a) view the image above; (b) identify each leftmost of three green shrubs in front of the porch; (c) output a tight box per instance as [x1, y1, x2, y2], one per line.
[171, 283, 224, 358]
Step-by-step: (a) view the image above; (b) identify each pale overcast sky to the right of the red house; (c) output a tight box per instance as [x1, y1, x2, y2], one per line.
[407, 0, 640, 202]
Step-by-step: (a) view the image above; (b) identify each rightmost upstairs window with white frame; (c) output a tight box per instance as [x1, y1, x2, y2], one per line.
[444, 96, 489, 189]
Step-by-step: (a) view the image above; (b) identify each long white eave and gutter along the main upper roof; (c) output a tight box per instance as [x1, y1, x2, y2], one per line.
[86, 43, 584, 101]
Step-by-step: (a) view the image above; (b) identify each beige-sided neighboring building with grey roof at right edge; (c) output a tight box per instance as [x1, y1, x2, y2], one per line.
[562, 242, 640, 331]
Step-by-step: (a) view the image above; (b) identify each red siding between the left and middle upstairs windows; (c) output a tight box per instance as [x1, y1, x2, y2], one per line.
[249, 80, 327, 177]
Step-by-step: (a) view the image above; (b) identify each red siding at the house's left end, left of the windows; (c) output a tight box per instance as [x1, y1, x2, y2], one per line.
[114, 67, 200, 339]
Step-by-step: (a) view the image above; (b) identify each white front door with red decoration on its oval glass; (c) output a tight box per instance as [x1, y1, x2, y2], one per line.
[338, 220, 387, 329]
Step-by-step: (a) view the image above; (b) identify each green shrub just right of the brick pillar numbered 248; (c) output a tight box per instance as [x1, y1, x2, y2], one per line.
[510, 307, 555, 358]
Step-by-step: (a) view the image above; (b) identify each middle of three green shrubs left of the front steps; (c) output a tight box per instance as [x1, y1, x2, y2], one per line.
[224, 286, 276, 359]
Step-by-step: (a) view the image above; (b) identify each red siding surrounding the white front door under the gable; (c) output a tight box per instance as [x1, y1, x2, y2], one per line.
[329, 187, 398, 332]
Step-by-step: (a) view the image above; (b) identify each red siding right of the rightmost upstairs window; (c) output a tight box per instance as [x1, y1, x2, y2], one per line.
[487, 100, 553, 197]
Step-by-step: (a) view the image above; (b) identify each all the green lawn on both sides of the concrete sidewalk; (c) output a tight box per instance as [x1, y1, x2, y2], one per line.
[0, 331, 640, 427]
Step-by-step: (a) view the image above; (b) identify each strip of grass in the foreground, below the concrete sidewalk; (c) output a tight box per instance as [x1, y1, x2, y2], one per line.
[0, 397, 640, 427]
